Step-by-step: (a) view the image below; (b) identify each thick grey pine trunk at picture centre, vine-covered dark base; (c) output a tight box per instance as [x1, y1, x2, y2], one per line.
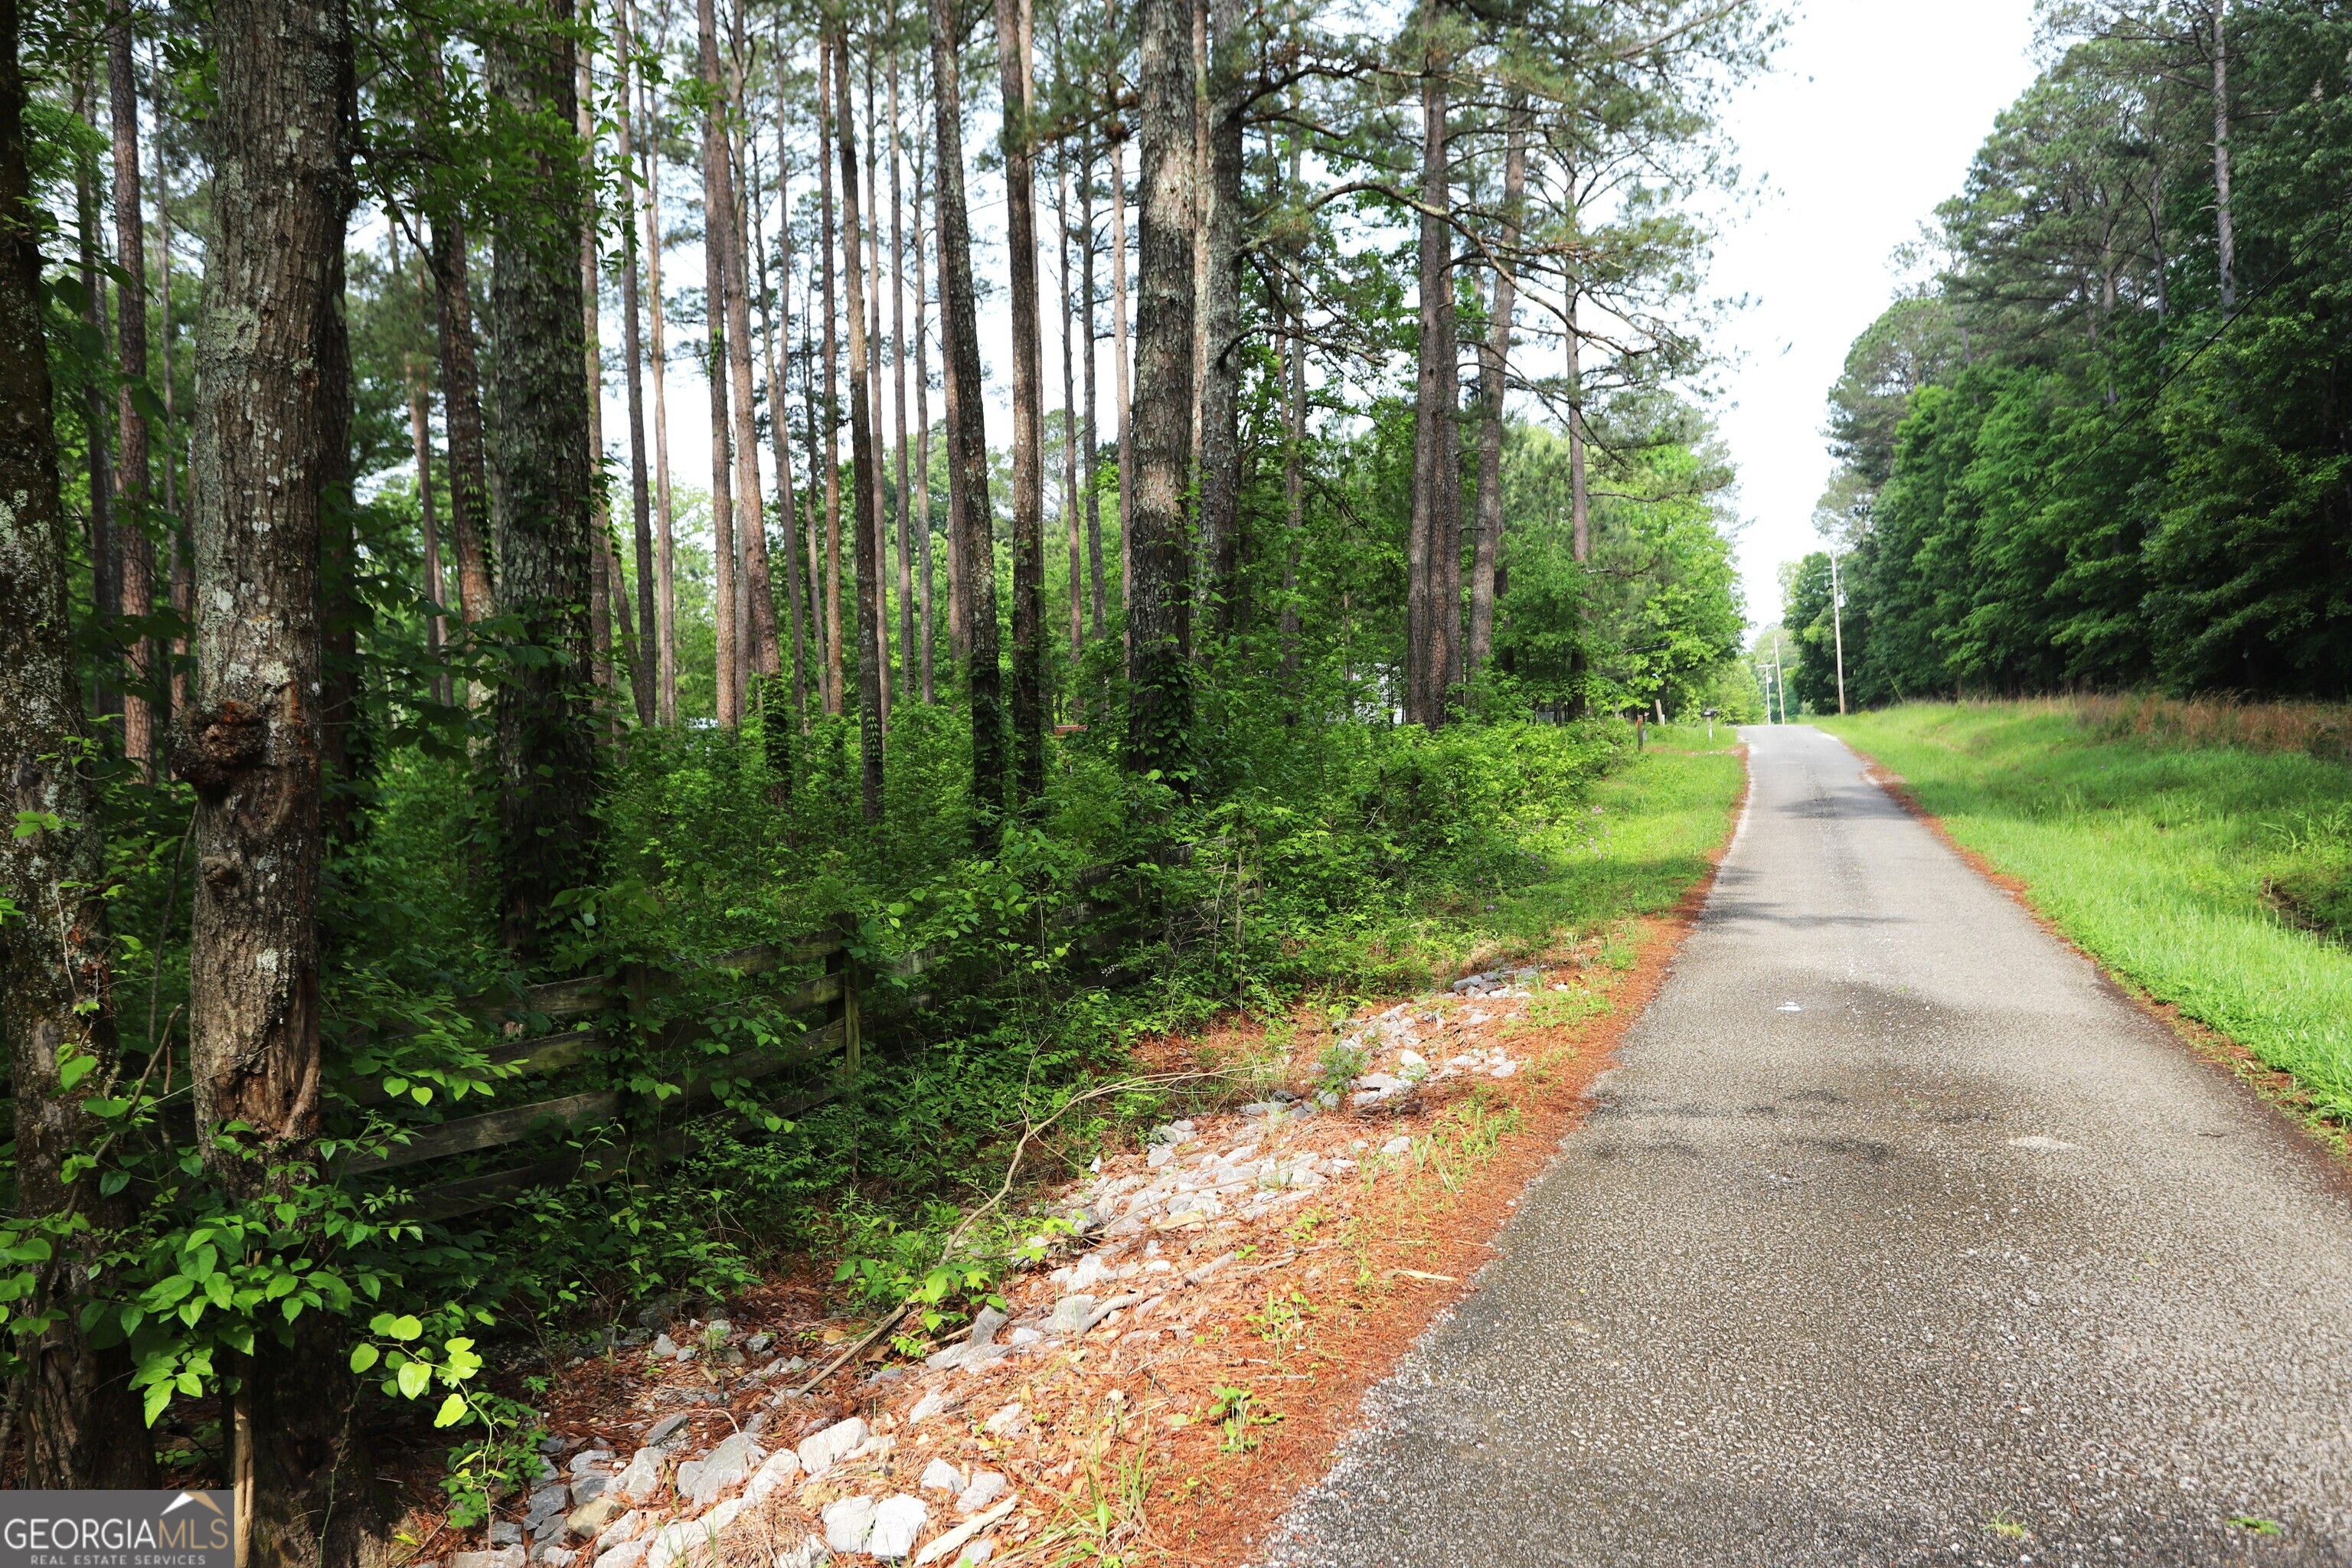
[1124, 0, 1197, 790]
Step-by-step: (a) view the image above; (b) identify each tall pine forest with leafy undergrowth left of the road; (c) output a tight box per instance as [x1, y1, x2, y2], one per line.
[0, 0, 1769, 1563]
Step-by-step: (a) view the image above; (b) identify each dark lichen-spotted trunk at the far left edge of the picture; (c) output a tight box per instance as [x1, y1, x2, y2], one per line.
[0, 0, 155, 1491]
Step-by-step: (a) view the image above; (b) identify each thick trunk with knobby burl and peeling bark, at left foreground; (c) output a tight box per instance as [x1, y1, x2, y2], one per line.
[188, 0, 395, 1563]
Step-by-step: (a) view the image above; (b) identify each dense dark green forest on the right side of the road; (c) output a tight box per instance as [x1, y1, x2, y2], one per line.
[1785, 0, 2352, 712]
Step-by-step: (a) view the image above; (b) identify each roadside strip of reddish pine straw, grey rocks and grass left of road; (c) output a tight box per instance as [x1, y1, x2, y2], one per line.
[390, 731, 1743, 1568]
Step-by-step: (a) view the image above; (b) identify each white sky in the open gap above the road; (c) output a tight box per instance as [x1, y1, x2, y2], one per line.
[1712, 0, 2034, 623]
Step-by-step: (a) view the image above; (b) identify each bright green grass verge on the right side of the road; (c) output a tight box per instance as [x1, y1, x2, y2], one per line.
[1818, 703, 2352, 1122]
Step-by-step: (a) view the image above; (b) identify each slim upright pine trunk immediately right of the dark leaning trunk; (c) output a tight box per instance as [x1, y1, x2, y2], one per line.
[998, 0, 1044, 804]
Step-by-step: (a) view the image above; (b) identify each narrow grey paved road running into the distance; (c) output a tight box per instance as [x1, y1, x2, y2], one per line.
[1270, 729, 2352, 1568]
